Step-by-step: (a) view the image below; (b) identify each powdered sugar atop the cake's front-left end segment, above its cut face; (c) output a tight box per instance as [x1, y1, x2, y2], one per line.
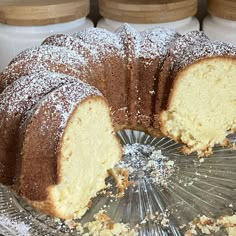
[23, 81, 102, 139]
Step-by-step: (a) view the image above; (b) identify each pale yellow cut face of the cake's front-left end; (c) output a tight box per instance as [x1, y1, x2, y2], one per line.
[49, 97, 120, 217]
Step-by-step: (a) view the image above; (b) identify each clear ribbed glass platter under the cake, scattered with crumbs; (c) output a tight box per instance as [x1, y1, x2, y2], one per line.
[0, 130, 236, 236]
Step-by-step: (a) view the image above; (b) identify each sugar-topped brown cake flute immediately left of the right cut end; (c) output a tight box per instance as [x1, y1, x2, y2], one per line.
[137, 27, 179, 128]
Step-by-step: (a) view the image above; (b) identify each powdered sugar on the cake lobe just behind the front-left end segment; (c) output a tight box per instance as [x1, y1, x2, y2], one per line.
[0, 71, 77, 115]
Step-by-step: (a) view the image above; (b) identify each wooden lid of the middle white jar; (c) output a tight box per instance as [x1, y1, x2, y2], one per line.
[99, 0, 197, 24]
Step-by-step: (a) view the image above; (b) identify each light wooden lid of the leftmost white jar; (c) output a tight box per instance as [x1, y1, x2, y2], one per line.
[0, 0, 89, 26]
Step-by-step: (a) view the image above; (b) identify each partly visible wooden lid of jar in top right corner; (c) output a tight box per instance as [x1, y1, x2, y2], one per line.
[208, 0, 236, 20]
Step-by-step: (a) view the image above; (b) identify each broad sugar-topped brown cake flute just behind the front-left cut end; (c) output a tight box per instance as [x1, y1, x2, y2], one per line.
[75, 28, 129, 124]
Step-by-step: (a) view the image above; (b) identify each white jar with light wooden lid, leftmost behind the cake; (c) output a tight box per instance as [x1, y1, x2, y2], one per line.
[0, 0, 94, 70]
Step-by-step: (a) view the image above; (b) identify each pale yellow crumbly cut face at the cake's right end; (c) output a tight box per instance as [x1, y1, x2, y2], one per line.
[161, 58, 236, 156]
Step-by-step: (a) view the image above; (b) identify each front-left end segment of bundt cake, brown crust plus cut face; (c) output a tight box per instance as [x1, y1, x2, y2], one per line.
[16, 82, 122, 219]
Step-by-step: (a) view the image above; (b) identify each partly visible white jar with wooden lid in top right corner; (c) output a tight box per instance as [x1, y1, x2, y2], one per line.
[202, 0, 236, 45]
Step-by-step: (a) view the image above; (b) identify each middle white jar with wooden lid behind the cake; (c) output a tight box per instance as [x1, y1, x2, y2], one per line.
[97, 0, 199, 33]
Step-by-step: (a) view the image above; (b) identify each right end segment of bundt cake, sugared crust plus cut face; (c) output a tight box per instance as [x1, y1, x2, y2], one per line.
[160, 31, 236, 156]
